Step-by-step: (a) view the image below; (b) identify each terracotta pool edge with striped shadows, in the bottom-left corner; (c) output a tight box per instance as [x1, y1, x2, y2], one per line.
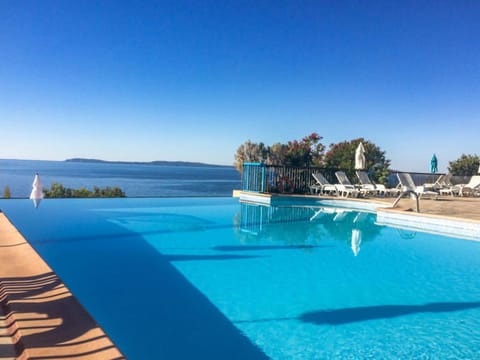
[0, 212, 126, 360]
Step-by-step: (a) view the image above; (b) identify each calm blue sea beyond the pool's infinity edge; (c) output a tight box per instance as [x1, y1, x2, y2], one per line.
[0, 159, 241, 198]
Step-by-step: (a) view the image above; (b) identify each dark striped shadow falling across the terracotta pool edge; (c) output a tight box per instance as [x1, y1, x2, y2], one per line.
[0, 268, 124, 359]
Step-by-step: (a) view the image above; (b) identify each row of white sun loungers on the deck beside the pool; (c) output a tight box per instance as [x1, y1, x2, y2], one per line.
[310, 170, 480, 198]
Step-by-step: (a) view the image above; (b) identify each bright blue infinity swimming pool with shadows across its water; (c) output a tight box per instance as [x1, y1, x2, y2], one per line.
[0, 198, 480, 359]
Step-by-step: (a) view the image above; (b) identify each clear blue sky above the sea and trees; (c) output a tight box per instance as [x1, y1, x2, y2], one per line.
[0, 0, 480, 171]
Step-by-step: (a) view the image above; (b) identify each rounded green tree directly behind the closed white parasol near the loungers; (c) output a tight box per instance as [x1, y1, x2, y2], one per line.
[324, 138, 390, 184]
